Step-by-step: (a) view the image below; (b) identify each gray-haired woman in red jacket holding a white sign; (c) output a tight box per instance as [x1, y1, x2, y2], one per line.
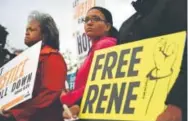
[0, 11, 67, 121]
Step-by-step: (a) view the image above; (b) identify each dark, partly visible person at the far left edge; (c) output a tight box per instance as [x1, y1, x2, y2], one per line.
[0, 25, 15, 67]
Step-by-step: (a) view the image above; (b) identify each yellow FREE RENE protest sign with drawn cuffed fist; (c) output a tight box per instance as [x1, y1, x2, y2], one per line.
[79, 32, 186, 121]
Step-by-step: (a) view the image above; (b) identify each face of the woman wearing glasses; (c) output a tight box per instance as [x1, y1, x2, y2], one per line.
[84, 9, 110, 39]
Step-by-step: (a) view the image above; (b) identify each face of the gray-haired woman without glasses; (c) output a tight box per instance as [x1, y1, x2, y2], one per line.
[25, 20, 42, 46]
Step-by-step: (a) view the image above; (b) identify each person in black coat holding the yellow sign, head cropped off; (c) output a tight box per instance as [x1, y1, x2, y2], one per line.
[119, 0, 187, 121]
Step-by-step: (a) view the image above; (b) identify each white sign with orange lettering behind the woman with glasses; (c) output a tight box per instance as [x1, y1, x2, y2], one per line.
[73, 0, 96, 64]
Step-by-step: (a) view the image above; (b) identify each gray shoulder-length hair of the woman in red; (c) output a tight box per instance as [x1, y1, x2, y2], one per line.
[28, 11, 59, 50]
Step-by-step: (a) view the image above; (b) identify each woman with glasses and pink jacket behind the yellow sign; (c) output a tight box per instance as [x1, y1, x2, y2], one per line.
[60, 7, 118, 118]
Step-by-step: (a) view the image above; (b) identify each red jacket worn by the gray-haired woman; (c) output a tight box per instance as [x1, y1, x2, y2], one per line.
[10, 46, 67, 121]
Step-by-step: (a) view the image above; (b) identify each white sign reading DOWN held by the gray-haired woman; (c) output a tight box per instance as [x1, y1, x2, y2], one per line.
[0, 42, 42, 110]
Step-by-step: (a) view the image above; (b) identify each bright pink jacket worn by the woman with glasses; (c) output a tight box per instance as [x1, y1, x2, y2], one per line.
[60, 37, 117, 106]
